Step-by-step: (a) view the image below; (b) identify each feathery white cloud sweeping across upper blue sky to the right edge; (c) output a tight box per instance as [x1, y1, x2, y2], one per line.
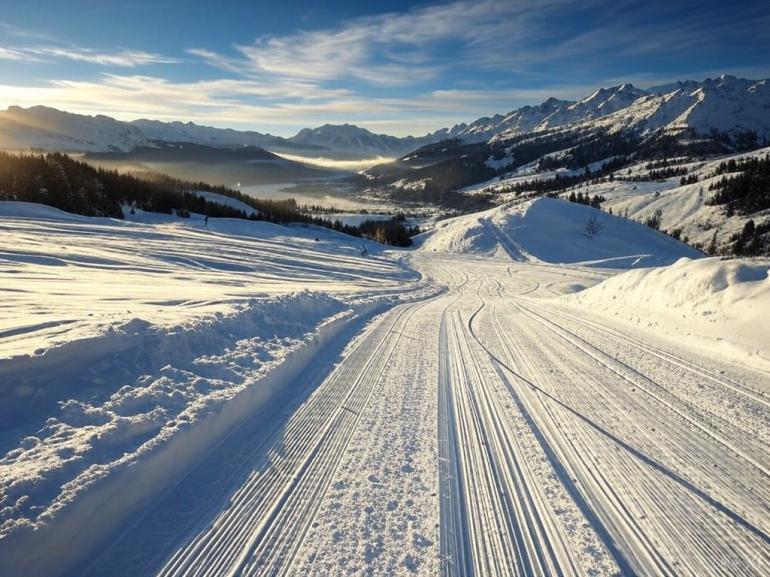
[190, 0, 770, 85]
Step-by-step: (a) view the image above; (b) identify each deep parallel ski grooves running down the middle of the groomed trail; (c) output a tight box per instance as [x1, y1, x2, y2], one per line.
[442, 274, 581, 576]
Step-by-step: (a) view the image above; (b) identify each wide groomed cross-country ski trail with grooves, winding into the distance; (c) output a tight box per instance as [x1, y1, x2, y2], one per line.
[1, 199, 770, 577]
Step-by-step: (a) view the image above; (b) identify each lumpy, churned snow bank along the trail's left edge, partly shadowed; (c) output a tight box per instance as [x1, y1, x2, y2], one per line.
[0, 293, 340, 524]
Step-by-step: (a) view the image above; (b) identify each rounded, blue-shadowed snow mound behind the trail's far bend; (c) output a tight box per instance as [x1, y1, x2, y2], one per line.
[421, 198, 701, 269]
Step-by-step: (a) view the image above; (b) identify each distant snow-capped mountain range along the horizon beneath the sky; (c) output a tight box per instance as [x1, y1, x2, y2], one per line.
[0, 75, 770, 158]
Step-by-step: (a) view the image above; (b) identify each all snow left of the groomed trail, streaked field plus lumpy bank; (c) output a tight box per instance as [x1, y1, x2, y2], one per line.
[0, 202, 432, 572]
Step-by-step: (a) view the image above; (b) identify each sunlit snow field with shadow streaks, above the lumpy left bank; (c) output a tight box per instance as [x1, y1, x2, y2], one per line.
[0, 203, 410, 355]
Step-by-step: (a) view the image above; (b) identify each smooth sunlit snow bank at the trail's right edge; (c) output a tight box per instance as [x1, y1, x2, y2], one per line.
[561, 258, 770, 370]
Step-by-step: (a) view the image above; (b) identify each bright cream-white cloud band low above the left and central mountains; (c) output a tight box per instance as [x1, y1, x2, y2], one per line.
[0, 74, 520, 135]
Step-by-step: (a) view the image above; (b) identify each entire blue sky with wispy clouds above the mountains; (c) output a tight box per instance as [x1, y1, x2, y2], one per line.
[0, 0, 770, 136]
